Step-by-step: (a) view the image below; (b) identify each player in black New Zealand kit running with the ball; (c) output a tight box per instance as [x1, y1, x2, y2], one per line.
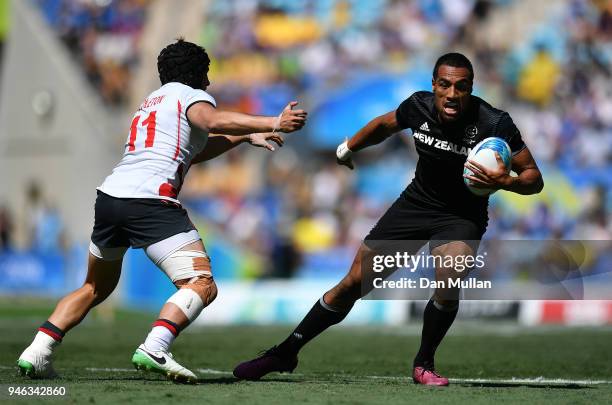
[234, 53, 544, 386]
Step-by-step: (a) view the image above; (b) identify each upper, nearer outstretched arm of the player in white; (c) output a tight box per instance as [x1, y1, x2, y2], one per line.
[187, 101, 308, 135]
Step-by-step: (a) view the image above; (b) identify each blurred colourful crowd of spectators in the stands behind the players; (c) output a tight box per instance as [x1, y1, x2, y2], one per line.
[20, 0, 612, 276]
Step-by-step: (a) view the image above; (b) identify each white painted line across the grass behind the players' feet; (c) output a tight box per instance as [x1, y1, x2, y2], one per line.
[0, 365, 612, 385]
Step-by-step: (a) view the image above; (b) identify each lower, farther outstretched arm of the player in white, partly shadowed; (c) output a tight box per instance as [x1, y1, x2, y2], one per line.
[191, 132, 284, 164]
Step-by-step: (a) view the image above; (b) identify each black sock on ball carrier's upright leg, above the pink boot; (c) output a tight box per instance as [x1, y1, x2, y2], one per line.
[414, 300, 459, 369]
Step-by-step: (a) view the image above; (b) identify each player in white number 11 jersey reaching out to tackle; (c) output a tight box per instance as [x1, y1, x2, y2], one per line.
[17, 39, 307, 382]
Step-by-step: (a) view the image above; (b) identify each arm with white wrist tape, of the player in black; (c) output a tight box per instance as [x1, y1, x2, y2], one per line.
[336, 111, 402, 169]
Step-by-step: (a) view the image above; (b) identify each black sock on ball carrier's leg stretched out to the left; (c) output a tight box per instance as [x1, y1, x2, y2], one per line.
[278, 298, 350, 356]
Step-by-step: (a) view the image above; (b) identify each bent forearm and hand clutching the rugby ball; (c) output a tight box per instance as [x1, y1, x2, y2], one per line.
[464, 148, 544, 195]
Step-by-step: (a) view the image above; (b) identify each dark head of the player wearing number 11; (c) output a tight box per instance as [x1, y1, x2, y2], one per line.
[157, 38, 210, 89]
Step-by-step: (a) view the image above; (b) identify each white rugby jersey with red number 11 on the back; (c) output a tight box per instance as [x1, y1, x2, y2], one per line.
[98, 82, 216, 202]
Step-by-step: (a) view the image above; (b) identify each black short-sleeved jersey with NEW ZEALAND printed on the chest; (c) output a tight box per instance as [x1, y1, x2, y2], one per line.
[396, 91, 525, 223]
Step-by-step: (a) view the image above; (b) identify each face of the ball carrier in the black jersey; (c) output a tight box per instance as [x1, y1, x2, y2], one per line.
[431, 65, 472, 122]
